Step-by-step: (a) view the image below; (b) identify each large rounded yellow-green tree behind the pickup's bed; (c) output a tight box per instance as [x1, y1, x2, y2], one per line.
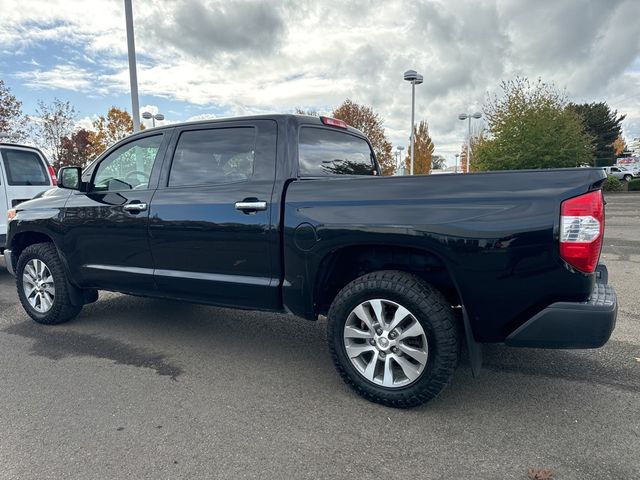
[471, 77, 593, 170]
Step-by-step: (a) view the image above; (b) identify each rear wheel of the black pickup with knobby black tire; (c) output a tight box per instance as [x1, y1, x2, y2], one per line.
[327, 271, 460, 408]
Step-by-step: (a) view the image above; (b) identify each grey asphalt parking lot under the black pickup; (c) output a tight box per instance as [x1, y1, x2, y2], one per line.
[0, 194, 640, 479]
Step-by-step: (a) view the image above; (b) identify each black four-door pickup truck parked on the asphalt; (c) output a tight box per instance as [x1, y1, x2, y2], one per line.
[4, 115, 617, 407]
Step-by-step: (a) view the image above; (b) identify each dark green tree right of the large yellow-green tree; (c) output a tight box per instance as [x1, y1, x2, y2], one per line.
[567, 102, 626, 167]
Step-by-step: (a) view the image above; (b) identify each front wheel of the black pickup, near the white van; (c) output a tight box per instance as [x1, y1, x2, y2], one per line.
[16, 243, 82, 325]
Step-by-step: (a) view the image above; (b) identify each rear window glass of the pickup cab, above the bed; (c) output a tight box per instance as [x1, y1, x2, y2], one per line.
[298, 127, 376, 177]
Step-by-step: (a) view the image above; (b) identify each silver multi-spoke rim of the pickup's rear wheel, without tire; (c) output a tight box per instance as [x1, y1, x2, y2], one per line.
[343, 298, 429, 388]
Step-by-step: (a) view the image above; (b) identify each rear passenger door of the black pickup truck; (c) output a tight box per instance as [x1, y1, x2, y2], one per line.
[149, 120, 280, 309]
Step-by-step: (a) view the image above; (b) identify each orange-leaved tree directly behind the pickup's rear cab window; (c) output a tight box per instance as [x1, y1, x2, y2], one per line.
[332, 99, 396, 175]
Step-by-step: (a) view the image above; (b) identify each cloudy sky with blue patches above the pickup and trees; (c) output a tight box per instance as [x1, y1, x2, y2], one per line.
[0, 0, 640, 165]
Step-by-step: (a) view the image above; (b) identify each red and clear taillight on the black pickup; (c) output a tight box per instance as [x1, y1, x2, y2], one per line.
[560, 190, 604, 273]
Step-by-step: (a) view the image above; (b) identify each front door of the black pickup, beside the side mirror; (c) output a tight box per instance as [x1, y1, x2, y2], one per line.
[62, 130, 170, 294]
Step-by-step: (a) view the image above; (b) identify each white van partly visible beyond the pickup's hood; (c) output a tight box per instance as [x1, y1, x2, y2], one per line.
[0, 143, 57, 252]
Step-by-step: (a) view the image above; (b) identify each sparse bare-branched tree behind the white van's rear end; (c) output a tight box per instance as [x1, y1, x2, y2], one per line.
[32, 98, 76, 166]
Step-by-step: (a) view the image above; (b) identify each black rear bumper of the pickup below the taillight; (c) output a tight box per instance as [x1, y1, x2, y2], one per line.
[505, 280, 618, 348]
